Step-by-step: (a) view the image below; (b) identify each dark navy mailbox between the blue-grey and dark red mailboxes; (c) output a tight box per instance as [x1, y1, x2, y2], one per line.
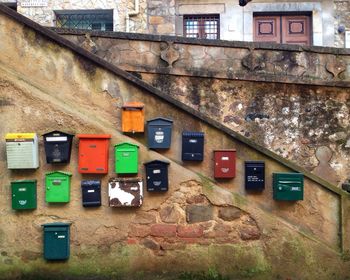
[182, 131, 204, 161]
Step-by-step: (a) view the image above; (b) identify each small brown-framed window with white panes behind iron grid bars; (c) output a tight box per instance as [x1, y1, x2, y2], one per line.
[184, 15, 220, 39]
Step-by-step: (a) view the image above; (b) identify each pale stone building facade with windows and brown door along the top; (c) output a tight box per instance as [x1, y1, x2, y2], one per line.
[2, 0, 350, 47]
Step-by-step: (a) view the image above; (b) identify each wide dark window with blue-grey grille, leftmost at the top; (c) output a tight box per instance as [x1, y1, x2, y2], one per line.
[55, 10, 113, 31]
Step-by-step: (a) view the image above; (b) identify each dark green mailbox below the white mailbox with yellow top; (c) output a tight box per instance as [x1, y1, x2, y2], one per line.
[11, 180, 37, 210]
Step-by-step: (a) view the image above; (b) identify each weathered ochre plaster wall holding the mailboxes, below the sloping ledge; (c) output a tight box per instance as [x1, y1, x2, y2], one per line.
[0, 7, 350, 279]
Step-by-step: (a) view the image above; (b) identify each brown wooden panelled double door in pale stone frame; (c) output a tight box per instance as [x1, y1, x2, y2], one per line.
[254, 14, 312, 46]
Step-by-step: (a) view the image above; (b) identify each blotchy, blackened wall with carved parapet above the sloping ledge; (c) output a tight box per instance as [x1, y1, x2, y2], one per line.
[55, 31, 350, 184]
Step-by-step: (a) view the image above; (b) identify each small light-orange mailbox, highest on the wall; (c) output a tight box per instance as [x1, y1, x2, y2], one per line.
[122, 102, 145, 133]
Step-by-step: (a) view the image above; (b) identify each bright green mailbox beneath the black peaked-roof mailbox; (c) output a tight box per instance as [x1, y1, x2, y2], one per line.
[45, 171, 72, 202]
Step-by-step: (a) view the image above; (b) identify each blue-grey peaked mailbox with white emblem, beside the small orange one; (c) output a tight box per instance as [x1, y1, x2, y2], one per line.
[147, 118, 173, 149]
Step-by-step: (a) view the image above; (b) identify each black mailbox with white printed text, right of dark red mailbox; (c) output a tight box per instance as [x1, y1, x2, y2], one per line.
[245, 161, 265, 191]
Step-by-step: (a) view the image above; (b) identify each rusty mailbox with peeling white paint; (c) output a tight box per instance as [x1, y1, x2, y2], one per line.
[108, 178, 143, 207]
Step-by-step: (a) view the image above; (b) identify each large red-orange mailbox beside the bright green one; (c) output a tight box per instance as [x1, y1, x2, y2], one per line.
[77, 134, 111, 174]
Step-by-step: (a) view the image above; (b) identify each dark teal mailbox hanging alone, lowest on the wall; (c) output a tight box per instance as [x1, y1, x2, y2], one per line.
[42, 223, 70, 260]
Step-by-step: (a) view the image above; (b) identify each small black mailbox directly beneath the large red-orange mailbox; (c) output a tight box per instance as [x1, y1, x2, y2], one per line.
[81, 180, 101, 207]
